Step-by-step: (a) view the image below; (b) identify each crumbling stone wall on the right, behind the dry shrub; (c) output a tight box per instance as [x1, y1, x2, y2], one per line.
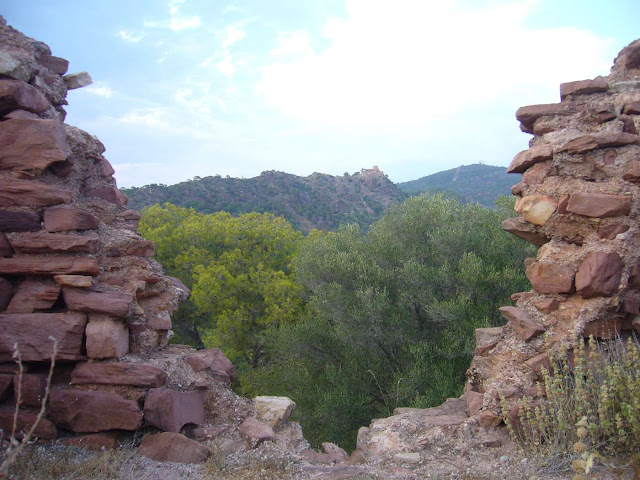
[466, 41, 640, 426]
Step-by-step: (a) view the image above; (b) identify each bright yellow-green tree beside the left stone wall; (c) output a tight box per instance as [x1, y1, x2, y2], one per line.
[140, 204, 303, 366]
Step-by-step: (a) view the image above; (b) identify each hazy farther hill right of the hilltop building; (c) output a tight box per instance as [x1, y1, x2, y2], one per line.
[397, 164, 520, 207]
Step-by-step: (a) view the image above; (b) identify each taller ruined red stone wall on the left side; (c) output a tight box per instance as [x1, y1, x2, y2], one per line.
[0, 17, 235, 438]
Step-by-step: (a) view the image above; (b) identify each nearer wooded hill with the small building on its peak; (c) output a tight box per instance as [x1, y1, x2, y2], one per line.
[122, 167, 406, 232]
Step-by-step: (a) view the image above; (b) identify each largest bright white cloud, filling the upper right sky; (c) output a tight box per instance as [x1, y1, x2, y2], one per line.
[258, 0, 611, 132]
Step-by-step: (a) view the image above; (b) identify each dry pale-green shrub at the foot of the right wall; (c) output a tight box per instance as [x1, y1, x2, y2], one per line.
[502, 336, 640, 473]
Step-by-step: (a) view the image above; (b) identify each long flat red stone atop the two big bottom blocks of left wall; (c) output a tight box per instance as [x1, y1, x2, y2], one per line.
[71, 362, 166, 388]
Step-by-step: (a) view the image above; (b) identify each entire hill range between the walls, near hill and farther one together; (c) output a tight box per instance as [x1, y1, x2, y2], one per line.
[122, 164, 517, 233]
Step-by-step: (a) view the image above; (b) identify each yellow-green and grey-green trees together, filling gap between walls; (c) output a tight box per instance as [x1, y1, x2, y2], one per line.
[141, 195, 533, 447]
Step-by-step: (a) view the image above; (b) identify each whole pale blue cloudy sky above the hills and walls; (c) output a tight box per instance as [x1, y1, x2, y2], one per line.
[0, 0, 640, 187]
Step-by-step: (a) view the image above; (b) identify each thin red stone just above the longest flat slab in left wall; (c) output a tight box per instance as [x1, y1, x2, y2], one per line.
[11, 232, 100, 253]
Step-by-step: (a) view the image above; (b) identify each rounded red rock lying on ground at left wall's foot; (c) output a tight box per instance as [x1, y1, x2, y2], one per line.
[137, 432, 209, 463]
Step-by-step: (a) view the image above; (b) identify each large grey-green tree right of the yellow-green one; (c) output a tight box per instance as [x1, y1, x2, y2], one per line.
[247, 196, 532, 447]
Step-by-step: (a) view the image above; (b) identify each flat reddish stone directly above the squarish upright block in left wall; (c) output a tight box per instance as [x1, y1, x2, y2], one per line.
[63, 288, 133, 318]
